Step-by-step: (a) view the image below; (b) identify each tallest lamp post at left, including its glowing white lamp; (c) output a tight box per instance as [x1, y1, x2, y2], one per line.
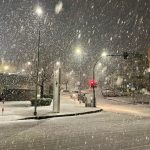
[34, 6, 43, 116]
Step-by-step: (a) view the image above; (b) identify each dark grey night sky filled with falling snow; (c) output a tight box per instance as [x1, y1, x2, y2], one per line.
[0, 0, 150, 71]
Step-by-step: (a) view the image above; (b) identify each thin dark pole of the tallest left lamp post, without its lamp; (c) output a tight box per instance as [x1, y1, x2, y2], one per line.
[34, 26, 40, 116]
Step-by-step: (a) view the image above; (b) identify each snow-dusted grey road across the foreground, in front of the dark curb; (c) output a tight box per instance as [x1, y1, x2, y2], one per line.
[0, 111, 150, 150]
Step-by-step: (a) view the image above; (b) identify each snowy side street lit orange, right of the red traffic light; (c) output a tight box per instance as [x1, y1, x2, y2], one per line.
[97, 96, 150, 117]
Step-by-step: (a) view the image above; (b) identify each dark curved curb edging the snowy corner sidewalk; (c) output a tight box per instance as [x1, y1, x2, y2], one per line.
[18, 109, 103, 120]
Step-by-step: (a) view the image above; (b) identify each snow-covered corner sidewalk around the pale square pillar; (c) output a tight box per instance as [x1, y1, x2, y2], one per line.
[0, 95, 102, 123]
